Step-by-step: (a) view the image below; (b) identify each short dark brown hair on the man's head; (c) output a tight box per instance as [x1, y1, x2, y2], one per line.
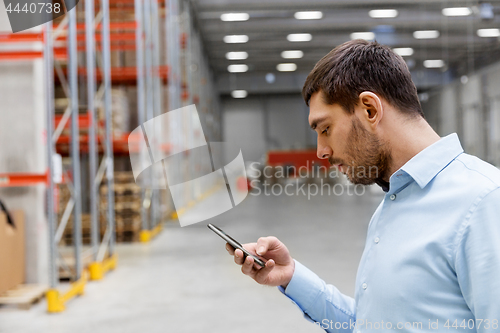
[302, 39, 424, 117]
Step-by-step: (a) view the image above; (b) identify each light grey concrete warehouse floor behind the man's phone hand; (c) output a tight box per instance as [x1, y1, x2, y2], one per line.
[0, 184, 382, 333]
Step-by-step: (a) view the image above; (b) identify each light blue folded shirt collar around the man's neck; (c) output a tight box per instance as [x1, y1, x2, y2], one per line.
[390, 133, 464, 192]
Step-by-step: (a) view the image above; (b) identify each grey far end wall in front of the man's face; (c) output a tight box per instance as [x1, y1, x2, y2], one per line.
[222, 94, 316, 161]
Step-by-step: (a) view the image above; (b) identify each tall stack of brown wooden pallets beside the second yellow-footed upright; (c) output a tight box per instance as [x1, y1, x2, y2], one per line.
[101, 172, 141, 242]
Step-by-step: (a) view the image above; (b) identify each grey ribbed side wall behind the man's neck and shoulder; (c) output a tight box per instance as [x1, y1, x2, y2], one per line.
[422, 63, 500, 166]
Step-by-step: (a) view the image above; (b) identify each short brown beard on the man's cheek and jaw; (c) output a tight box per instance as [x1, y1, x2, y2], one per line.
[328, 117, 391, 185]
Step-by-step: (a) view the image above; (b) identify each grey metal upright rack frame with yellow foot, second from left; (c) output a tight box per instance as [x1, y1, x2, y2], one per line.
[85, 0, 117, 280]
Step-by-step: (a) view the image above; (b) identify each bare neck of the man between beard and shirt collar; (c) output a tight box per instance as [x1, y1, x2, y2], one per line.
[384, 118, 441, 182]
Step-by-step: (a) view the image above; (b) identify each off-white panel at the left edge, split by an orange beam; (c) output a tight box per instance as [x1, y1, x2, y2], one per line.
[0, 60, 48, 283]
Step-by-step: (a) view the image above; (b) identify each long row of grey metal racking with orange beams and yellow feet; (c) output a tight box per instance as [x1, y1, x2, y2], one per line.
[0, 0, 221, 312]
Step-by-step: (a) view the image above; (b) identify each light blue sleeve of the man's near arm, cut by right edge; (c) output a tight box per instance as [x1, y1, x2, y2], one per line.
[455, 188, 500, 333]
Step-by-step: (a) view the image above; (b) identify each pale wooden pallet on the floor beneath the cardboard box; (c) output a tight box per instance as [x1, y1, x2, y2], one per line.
[0, 284, 48, 310]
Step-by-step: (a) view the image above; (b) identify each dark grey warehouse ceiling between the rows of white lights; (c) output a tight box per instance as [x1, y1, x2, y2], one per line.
[192, 0, 500, 91]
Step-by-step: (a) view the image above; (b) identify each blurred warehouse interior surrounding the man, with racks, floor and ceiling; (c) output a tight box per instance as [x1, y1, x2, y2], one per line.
[0, 0, 500, 333]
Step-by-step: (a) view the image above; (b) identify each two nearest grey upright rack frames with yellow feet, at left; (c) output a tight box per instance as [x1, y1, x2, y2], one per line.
[44, 0, 117, 312]
